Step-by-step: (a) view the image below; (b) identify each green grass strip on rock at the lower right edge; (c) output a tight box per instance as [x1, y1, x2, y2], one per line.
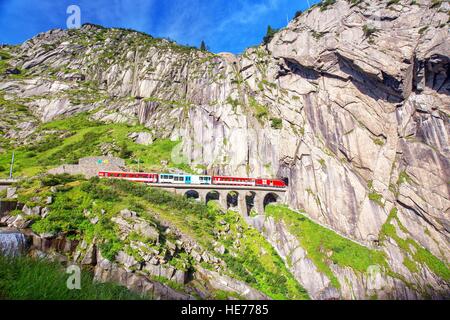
[379, 208, 450, 281]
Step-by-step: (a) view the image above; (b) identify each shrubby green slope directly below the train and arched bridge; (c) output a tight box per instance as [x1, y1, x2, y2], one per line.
[13, 176, 308, 299]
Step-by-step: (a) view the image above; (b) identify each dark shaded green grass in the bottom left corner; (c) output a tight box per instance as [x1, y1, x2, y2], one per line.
[0, 256, 147, 300]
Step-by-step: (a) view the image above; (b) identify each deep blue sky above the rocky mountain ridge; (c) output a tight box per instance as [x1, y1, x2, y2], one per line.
[0, 0, 318, 53]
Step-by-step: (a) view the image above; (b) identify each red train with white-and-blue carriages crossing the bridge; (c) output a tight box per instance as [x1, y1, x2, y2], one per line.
[98, 171, 287, 188]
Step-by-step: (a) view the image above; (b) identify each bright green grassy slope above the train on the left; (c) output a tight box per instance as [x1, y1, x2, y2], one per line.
[0, 114, 189, 177]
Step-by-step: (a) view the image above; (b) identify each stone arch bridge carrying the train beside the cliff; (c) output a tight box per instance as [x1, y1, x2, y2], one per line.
[148, 183, 287, 217]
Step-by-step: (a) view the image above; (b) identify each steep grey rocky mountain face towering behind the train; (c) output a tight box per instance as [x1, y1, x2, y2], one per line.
[0, 0, 450, 298]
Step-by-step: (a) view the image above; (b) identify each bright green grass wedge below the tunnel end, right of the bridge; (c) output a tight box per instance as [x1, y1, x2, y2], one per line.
[266, 205, 388, 288]
